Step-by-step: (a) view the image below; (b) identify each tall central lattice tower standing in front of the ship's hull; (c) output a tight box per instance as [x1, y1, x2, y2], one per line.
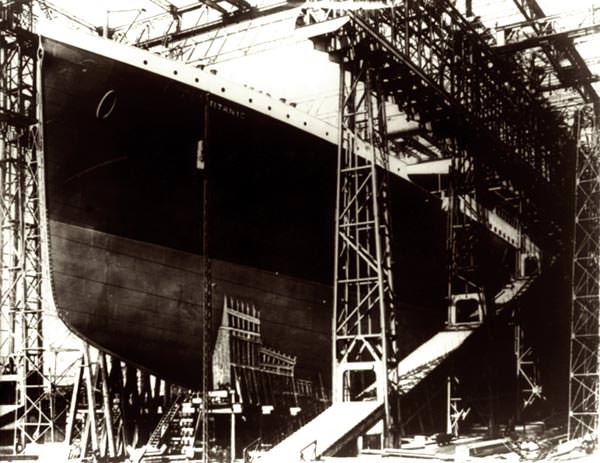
[333, 56, 396, 444]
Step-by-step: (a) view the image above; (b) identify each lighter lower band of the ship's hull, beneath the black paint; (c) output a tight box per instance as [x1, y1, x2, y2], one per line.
[50, 221, 331, 386]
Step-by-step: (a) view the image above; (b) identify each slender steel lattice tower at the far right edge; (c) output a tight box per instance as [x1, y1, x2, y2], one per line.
[568, 105, 600, 442]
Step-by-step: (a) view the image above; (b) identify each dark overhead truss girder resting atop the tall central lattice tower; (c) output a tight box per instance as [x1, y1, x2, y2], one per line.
[313, 1, 573, 256]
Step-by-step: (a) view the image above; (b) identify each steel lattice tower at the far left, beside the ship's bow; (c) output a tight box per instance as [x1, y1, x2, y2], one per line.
[0, 1, 54, 450]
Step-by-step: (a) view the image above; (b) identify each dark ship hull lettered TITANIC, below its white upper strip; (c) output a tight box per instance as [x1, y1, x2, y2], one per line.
[42, 33, 445, 386]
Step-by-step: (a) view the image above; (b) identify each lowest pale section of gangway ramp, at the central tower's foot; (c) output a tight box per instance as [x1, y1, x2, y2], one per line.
[260, 401, 383, 463]
